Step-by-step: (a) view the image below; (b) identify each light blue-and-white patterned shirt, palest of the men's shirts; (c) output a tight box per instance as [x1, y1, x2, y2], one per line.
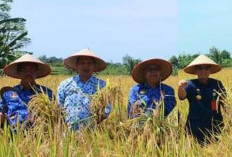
[57, 75, 112, 130]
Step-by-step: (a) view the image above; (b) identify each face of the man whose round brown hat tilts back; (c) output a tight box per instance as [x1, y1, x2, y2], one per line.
[145, 64, 161, 84]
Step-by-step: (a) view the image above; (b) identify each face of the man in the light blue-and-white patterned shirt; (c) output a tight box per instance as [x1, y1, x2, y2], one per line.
[76, 57, 95, 77]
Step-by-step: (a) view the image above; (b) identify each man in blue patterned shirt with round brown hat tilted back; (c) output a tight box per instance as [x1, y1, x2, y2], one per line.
[127, 59, 176, 118]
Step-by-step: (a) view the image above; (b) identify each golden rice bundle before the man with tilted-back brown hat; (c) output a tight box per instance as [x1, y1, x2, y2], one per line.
[120, 95, 178, 143]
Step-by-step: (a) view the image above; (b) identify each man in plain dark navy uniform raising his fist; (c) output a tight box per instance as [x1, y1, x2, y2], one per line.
[178, 55, 226, 144]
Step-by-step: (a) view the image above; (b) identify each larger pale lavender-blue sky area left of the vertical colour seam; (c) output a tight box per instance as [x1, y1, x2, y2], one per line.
[11, 0, 178, 62]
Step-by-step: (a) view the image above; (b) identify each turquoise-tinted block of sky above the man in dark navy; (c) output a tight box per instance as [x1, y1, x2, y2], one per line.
[178, 0, 232, 53]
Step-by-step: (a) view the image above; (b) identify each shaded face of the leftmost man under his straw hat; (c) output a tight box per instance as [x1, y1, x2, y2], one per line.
[18, 63, 37, 83]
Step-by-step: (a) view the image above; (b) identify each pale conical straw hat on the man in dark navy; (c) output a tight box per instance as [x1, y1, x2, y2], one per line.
[184, 55, 222, 74]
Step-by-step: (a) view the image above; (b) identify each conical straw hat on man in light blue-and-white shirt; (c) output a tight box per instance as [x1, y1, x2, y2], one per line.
[64, 49, 107, 72]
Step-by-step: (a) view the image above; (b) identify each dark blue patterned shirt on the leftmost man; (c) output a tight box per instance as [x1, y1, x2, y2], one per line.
[0, 85, 53, 125]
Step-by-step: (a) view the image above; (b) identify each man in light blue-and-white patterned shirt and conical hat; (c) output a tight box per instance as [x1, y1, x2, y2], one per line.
[57, 49, 111, 130]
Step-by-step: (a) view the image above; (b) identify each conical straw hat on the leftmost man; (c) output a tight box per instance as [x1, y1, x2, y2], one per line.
[3, 54, 51, 79]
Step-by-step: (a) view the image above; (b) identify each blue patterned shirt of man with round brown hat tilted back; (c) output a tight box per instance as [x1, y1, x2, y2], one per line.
[127, 83, 176, 118]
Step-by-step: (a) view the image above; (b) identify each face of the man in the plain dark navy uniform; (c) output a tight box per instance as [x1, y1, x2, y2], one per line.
[195, 65, 211, 80]
